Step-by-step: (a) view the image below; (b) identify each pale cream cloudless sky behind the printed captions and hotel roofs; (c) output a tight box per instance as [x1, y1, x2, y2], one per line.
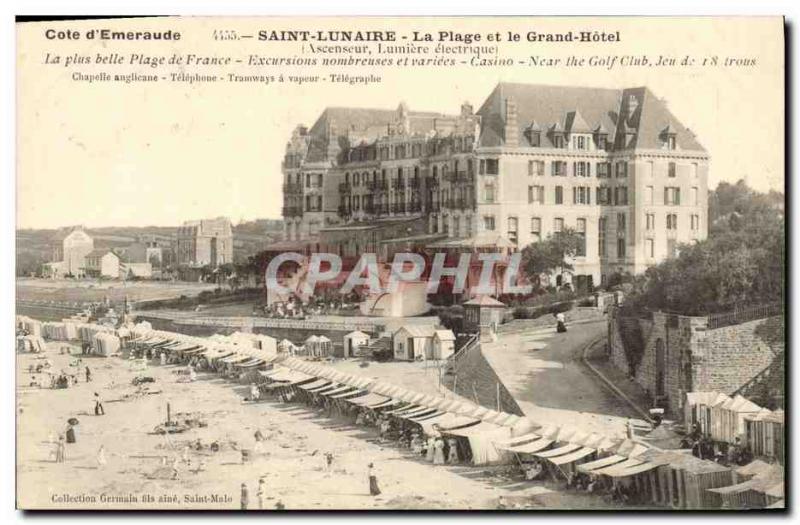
[17, 18, 784, 228]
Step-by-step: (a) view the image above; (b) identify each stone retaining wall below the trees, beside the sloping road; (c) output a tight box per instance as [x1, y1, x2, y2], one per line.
[608, 312, 785, 415]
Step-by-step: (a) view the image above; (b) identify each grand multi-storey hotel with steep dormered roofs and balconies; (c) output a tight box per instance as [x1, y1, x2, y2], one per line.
[283, 83, 709, 285]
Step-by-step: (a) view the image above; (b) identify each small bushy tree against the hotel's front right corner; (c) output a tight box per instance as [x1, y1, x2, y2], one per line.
[521, 228, 586, 287]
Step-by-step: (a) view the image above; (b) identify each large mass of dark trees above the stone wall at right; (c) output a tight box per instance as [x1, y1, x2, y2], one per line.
[626, 181, 785, 315]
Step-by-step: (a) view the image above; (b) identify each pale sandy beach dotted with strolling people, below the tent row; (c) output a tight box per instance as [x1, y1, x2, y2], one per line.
[17, 342, 620, 510]
